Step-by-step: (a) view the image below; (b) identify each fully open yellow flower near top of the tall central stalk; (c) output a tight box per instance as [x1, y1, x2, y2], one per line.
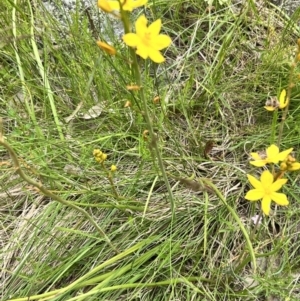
[123, 15, 172, 63]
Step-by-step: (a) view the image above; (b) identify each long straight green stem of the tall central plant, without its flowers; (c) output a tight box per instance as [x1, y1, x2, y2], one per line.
[121, 10, 175, 220]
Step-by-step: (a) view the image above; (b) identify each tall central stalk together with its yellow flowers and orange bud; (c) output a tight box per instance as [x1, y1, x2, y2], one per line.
[98, 0, 175, 218]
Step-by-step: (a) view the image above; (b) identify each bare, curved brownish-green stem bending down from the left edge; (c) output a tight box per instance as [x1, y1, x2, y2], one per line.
[0, 131, 119, 253]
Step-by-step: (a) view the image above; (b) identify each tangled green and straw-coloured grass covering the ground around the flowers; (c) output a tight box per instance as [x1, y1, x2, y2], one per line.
[0, 0, 300, 301]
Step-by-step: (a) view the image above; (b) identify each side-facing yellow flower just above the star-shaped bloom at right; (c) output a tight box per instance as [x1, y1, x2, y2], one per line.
[250, 144, 293, 167]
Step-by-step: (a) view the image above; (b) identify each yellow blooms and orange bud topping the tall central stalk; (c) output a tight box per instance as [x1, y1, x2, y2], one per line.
[97, 0, 172, 63]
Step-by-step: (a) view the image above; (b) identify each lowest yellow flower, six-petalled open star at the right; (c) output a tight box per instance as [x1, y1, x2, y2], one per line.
[245, 170, 289, 215]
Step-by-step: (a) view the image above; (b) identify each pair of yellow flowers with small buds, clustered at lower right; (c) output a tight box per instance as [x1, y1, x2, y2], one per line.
[245, 144, 300, 215]
